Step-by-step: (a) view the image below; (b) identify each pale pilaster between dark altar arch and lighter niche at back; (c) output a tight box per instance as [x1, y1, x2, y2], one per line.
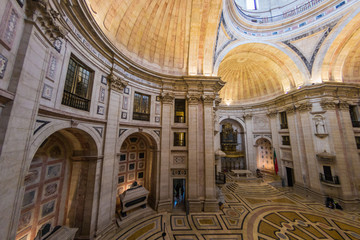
[244, 113, 257, 171]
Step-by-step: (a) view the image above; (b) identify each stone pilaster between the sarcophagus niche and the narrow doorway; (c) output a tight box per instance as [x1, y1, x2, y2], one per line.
[157, 93, 174, 212]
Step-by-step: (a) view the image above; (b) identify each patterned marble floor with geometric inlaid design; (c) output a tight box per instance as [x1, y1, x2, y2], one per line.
[112, 177, 360, 240]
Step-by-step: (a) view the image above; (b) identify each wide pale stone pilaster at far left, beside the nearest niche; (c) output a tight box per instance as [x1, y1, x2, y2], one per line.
[0, 21, 49, 239]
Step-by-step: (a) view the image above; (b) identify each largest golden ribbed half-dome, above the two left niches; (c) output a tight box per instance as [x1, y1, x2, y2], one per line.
[85, 0, 222, 75]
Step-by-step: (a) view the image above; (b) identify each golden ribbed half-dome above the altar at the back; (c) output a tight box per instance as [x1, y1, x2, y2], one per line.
[218, 43, 303, 105]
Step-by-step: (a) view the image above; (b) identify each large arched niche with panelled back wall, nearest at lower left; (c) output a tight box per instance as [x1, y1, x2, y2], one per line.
[16, 128, 100, 239]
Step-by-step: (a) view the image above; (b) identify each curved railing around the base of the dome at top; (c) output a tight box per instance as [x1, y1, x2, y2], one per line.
[234, 0, 324, 23]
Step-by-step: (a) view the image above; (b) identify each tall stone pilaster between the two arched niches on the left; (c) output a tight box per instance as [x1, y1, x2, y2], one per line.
[96, 73, 127, 234]
